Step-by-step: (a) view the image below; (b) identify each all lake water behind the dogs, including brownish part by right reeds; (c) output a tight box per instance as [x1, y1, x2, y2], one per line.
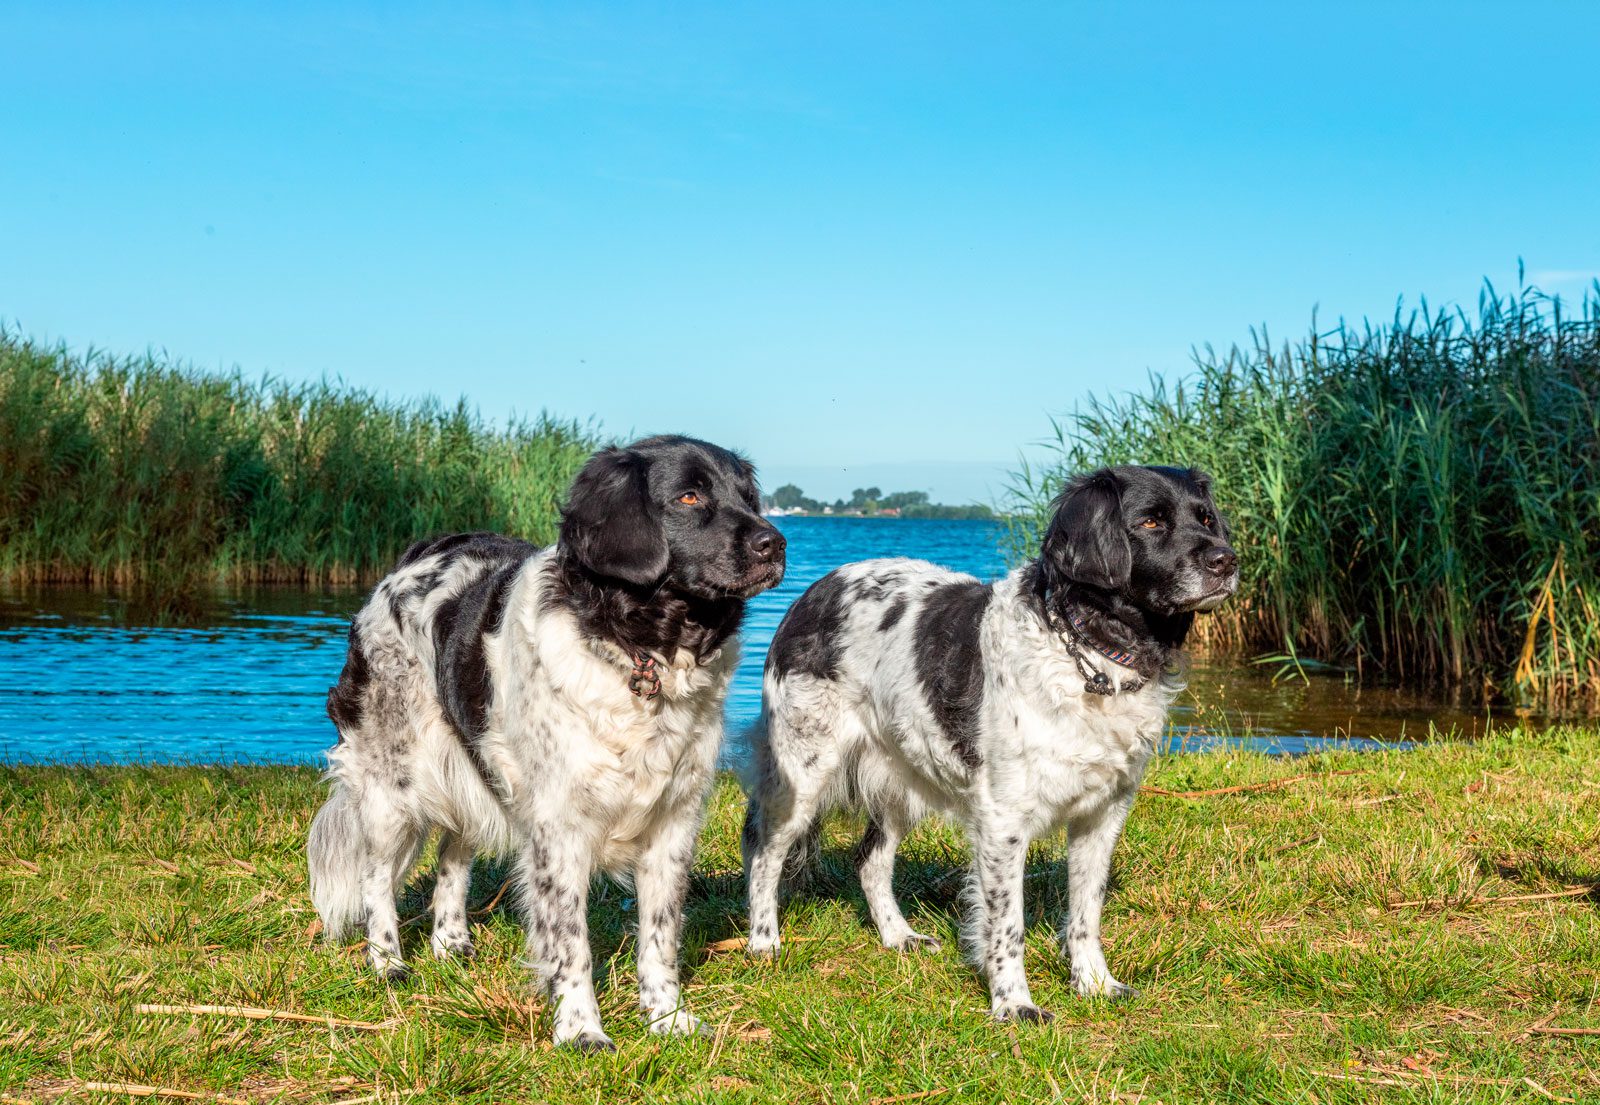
[0, 518, 1529, 763]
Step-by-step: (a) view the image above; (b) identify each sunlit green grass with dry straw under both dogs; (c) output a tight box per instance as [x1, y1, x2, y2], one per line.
[0, 728, 1600, 1105]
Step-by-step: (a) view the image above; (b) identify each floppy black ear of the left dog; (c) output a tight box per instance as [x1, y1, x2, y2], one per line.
[562, 448, 669, 584]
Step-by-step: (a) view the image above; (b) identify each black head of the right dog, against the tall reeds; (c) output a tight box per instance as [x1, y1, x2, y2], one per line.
[1040, 467, 1238, 617]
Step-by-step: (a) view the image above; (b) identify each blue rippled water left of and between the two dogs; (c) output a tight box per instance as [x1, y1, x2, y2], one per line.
[0, 518, 1005, 763]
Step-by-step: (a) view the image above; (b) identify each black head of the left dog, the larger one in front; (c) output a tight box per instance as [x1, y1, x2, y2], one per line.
[560, 437, 786, 600]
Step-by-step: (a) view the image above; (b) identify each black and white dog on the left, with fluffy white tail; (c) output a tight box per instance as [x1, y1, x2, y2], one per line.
[309, 437, 784, 1049]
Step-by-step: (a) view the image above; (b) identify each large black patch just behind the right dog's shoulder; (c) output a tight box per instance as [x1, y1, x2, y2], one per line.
[917, 580, 994, 768]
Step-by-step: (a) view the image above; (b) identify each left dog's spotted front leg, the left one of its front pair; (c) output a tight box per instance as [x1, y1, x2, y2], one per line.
[518, 832, 616, 1051]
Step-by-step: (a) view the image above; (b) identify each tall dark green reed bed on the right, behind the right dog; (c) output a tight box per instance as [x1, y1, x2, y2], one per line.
[1008, 283, 1600, 708]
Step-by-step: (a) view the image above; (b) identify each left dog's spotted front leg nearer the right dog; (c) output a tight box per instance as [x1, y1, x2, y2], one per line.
[634, 812, 704, 1036]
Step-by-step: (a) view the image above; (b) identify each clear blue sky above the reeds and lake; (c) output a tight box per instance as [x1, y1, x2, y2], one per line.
[0, 0, 1600, 501]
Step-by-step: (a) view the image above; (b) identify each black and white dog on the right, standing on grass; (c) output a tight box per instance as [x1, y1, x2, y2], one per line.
[744, 467, 1238, 1020]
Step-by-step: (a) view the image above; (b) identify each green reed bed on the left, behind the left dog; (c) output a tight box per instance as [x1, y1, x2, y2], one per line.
[0, 331, 597, 606]
